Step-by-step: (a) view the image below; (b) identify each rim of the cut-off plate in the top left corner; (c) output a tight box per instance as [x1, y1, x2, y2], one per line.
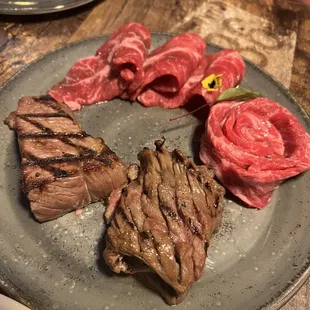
[0, 0, 96, 15]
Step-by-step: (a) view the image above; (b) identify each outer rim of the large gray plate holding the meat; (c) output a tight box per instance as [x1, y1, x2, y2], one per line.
[0, 32, 310, 310]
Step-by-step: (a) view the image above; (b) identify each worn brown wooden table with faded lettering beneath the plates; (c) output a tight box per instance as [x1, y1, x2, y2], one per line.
[0, 0, 310, 310]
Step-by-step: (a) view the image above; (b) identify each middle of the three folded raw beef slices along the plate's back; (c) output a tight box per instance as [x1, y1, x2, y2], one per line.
[129, 33, 206, 107]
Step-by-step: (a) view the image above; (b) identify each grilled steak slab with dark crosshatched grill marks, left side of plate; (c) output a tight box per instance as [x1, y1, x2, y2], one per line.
[6, 96, 127, 222]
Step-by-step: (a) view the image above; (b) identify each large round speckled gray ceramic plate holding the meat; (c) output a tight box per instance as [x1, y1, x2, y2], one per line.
[0, 34, 310, 310]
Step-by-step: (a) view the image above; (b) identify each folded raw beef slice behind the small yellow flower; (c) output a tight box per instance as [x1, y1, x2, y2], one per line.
[191, 49, 245, 106]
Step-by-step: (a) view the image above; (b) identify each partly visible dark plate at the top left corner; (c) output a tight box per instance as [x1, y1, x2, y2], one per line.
[0, 0, 94, 15]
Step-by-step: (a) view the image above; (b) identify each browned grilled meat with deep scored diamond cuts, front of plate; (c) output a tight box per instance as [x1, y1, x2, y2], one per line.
[103, 140, 224, 304]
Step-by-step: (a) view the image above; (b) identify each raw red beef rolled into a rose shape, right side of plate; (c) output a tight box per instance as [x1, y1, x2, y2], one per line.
[200, 98, 310, 208]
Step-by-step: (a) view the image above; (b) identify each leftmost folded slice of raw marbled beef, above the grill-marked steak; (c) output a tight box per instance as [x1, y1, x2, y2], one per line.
[49, 23, 151, 110]
